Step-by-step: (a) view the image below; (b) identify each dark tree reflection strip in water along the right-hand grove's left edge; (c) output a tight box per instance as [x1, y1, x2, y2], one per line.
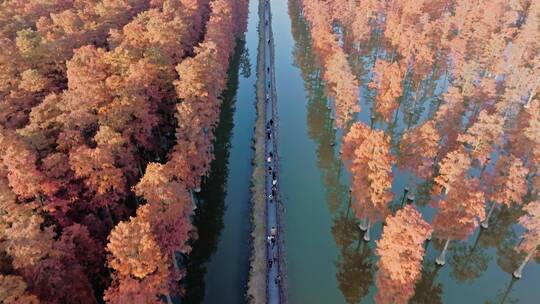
[289, 0, 375, 303]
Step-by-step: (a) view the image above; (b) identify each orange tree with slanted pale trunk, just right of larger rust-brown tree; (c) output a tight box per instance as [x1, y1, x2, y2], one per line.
[482, 155, 528, 228]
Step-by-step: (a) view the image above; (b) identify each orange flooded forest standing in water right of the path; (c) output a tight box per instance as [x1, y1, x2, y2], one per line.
[302, 0, 540, 303]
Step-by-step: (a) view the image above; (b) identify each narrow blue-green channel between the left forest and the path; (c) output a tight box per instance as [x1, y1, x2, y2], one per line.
[183, 1, 258, 304]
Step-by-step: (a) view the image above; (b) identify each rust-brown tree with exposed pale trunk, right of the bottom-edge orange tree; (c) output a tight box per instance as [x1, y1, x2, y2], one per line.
[432, 175, 485, 265]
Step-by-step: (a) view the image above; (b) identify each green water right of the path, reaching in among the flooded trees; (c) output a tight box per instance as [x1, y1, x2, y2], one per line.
[272, 0, 540, 304]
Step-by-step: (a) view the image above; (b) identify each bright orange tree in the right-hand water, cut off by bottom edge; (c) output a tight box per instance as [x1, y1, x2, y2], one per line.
[375, 205, 431, 304]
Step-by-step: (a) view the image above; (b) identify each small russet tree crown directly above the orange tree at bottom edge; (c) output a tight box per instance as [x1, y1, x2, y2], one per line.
[397, 120, 441, 179]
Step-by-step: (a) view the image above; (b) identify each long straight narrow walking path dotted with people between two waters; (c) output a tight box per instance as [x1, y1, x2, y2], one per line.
[261, 0, 286, 304]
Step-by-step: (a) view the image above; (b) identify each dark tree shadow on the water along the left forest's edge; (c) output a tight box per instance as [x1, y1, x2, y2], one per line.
[182, 39, 249, 303]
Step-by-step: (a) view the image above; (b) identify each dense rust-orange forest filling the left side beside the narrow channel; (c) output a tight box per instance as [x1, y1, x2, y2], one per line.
[0, 0, 248, 304]
